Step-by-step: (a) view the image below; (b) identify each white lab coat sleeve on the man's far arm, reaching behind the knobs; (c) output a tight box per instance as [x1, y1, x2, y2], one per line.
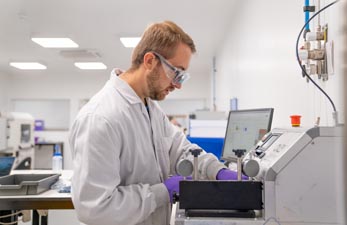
[164, 117, 226, 180]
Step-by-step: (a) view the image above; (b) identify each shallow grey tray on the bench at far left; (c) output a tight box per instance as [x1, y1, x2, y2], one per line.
[0, 174, 60, 196]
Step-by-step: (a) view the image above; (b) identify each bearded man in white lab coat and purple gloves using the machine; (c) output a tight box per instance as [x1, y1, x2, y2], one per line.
[70, 21, 239, 225]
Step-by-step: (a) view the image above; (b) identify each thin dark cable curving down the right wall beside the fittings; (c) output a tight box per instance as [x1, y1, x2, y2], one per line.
[296, 0, 339, 112]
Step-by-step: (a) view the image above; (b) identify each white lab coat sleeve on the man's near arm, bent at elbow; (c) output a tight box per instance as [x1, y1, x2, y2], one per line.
[70, 114, 169, 225]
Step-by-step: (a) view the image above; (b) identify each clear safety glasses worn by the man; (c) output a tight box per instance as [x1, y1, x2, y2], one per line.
[153, 52, 190, 85]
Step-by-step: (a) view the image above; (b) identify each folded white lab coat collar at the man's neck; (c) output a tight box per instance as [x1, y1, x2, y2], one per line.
[109, 70, 142, 104]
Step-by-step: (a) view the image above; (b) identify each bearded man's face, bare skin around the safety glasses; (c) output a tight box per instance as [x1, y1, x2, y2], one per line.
[147, 44, 192, 101]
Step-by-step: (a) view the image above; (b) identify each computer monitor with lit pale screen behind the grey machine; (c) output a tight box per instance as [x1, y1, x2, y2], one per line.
[221, 108, 274, 162]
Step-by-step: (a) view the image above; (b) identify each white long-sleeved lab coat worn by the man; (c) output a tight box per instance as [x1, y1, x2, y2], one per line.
[70, 72, 223, 225]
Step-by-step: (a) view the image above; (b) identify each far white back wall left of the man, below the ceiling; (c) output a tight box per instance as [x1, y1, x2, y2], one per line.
[8, 72, 109, 121]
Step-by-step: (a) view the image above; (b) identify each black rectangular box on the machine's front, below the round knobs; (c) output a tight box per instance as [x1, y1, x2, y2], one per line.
[179, 180, 263, 217]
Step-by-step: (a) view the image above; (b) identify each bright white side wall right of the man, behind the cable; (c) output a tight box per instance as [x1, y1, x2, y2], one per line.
[216, 0, 343, 126]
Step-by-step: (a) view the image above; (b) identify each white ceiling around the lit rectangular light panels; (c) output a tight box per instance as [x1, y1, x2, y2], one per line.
[0, 0, 236, 76]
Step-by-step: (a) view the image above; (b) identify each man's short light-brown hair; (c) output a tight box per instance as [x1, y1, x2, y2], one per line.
[130, 21, 196, 70]
